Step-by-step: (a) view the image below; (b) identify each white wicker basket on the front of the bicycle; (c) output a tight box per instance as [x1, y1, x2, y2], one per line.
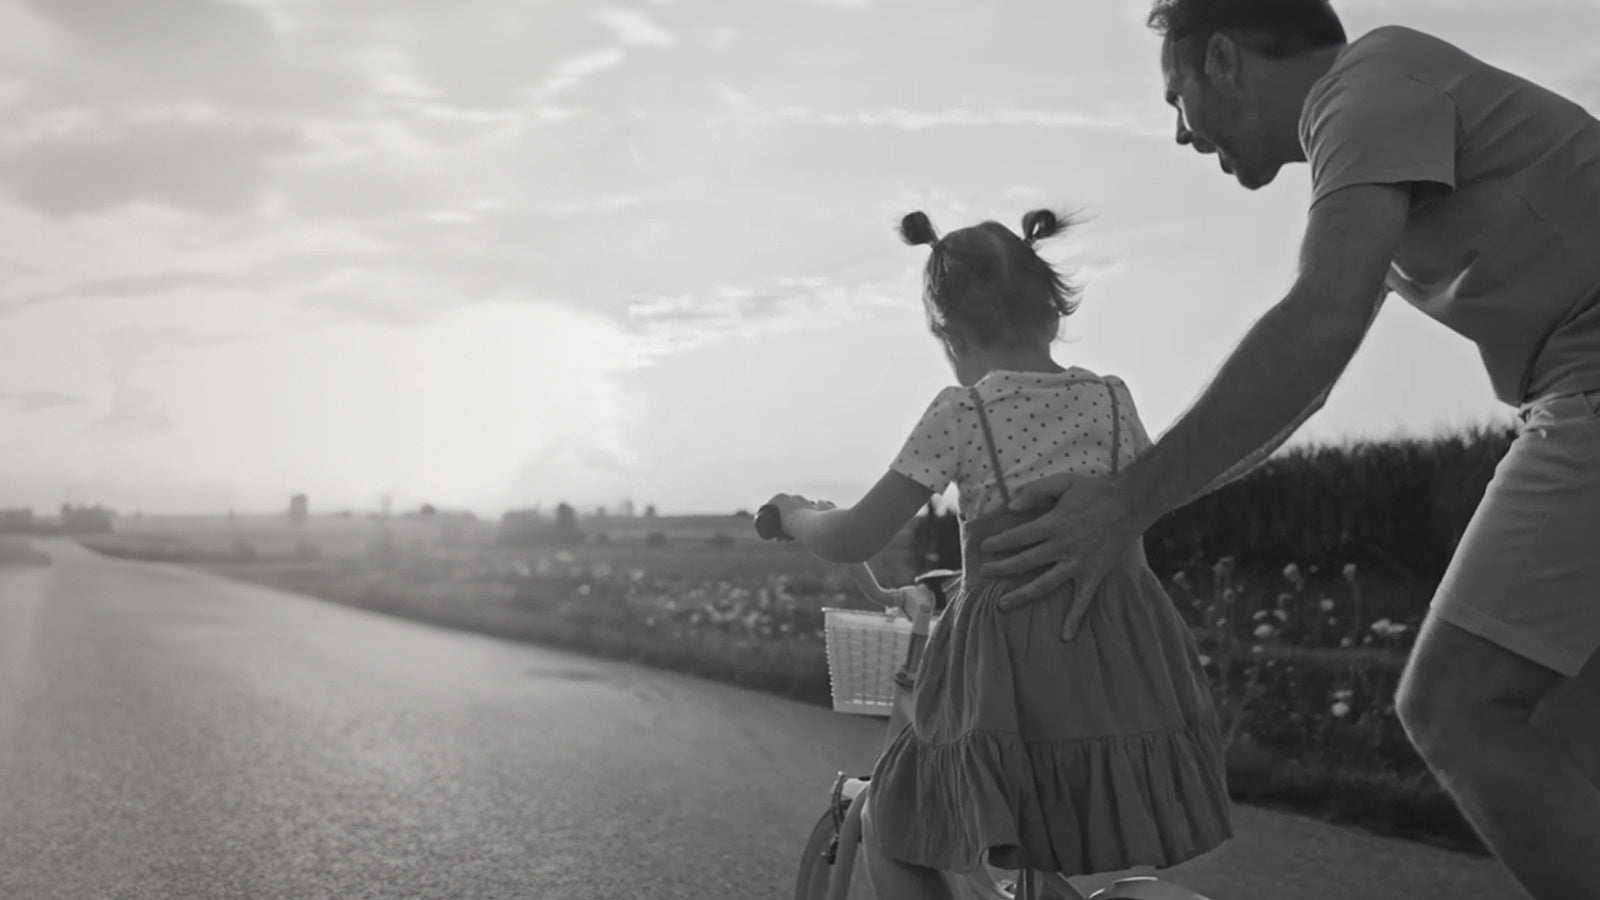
[822, 607, 910, 716]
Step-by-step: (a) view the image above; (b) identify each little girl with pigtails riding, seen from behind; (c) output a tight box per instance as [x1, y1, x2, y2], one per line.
[771, 210, 1234, 900]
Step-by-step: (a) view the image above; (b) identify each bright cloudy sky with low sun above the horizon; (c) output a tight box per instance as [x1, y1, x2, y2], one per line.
[0, 0, 1600, 516]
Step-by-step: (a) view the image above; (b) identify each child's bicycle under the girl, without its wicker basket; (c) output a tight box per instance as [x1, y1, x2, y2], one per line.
[755, 506, 1206, 900]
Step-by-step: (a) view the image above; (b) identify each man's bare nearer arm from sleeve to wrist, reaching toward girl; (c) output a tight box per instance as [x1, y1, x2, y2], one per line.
[1118, 184, 1411, 527]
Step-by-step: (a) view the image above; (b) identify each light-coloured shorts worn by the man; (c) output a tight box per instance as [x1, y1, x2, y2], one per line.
[1432, 384, 1600, 677]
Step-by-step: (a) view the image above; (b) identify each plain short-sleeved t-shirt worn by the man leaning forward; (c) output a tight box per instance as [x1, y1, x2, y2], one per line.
[1299, 26, 1600, 405]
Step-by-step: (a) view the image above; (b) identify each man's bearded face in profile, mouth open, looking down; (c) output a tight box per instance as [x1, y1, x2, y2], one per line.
[1162, 40, 1283, 191]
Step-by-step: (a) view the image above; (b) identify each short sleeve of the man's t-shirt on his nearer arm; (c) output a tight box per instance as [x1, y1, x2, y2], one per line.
[1301, 68, 1456, 205]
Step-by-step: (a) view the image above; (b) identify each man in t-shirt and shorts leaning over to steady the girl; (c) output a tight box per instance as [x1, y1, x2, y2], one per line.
[984, 0, 1600, 900]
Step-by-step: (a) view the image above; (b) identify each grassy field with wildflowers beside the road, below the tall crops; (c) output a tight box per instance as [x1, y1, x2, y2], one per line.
[72, 516, 1483, 854]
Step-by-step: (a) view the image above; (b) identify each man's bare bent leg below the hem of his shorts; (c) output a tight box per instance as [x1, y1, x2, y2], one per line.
[1397, 610, 1600, 900]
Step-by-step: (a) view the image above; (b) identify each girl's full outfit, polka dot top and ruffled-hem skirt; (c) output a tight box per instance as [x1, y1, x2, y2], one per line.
[872, 368, 1234, 876]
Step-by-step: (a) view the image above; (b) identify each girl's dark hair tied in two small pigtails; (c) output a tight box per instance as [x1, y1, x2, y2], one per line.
[899, 210, 1083, 346]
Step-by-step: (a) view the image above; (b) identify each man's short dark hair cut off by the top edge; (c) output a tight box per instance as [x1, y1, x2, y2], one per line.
[1147, 0, 1346, 56]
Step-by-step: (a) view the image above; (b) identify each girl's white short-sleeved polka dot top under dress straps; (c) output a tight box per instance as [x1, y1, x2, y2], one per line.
[890, 367, 1150, 520]
